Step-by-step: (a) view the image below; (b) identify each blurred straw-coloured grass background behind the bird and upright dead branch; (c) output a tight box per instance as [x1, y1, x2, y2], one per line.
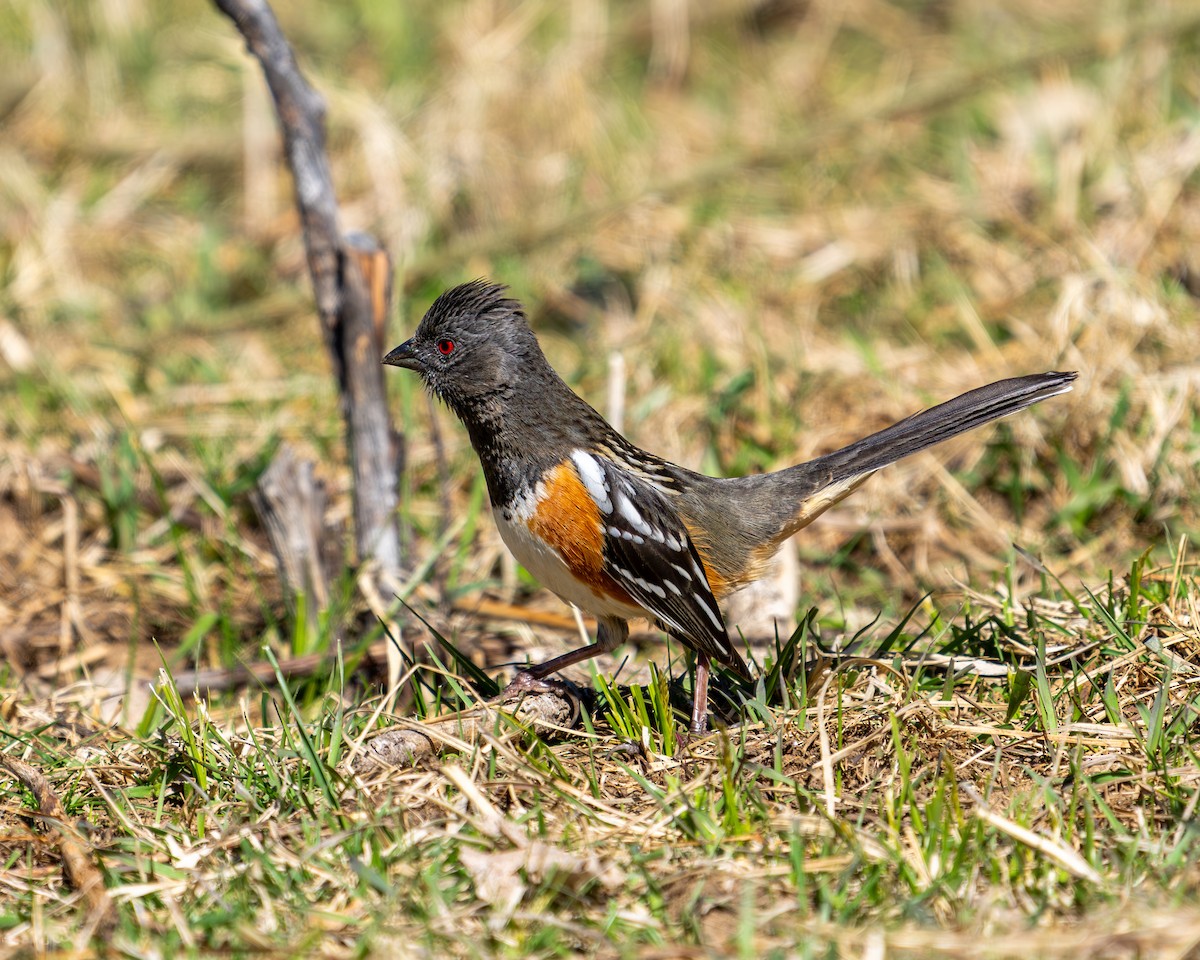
[0, 0, 1200, 691]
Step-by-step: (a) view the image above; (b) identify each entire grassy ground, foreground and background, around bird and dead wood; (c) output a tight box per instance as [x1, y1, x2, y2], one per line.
[0, 0, 1200, 956]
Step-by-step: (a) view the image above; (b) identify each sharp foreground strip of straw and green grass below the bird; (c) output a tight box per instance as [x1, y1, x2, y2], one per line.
[0, 566, 1200, 958]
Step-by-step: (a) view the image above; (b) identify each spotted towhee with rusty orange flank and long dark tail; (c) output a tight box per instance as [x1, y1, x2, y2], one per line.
[384, 281, 1076, 733]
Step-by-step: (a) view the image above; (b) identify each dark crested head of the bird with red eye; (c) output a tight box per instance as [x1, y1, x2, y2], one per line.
[383, 280, 546, 419]
